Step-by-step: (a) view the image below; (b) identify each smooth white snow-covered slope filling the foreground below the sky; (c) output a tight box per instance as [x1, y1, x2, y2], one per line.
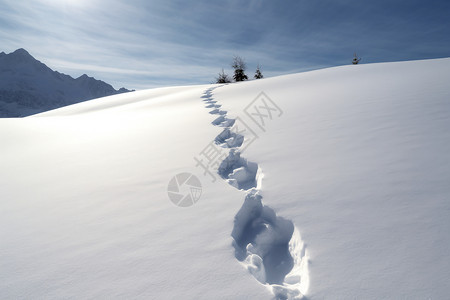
[0, 59, 450, 299]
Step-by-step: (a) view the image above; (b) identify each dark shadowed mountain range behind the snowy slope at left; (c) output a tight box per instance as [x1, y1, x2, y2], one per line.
[0, 49, 130, 117]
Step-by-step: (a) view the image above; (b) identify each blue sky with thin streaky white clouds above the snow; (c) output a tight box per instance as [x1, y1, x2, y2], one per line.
[0, 0, 450, 89]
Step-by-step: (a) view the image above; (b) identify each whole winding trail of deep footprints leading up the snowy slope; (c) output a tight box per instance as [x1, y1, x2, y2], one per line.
[201, 86, 309, 300]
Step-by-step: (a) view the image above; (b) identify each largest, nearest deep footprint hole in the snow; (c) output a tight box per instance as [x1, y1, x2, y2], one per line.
[231, 189, 309, 299]
